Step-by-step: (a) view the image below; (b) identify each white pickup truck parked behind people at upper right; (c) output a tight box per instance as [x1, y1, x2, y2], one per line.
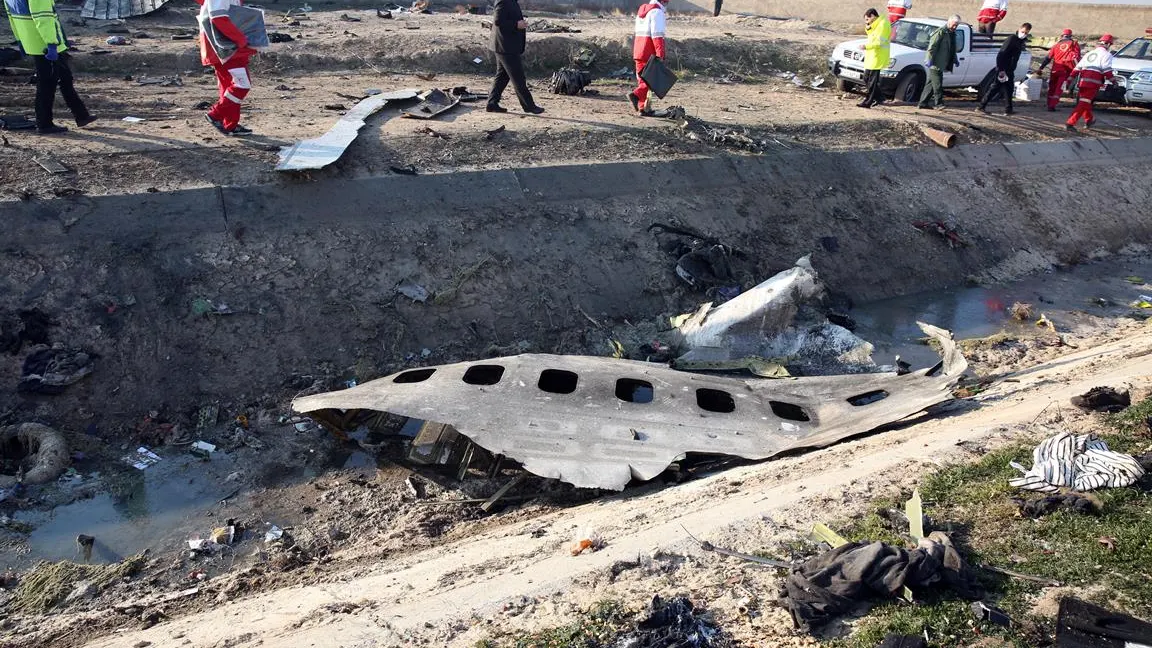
[828, 18, 1032, 103]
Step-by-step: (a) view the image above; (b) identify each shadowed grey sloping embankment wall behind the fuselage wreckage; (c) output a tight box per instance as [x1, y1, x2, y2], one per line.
[0, 138, 1152, 429]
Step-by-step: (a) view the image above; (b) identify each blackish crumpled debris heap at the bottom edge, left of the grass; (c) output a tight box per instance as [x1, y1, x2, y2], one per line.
[615, 595, 732, 648]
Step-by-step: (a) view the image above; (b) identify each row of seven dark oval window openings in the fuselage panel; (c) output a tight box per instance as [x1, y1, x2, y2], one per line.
[392, 364, 888, 421]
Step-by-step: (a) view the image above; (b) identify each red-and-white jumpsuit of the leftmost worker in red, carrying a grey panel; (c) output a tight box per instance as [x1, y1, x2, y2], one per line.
[196, 0, 255, 131]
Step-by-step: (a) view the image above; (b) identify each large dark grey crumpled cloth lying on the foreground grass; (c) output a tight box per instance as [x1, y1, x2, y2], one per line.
[780, 532, 983, 631]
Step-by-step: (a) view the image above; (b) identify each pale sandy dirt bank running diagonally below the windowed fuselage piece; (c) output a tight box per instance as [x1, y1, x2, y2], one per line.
[3, 311, 1152, 647]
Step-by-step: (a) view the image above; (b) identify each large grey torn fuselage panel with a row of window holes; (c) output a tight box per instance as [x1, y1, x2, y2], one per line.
[293, 324, 968, 490]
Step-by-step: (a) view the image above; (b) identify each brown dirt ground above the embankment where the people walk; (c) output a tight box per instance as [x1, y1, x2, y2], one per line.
[0, 0, 1152, 199]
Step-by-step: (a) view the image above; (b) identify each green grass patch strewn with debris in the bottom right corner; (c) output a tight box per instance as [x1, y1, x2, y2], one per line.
[829, 399, 1152, 648]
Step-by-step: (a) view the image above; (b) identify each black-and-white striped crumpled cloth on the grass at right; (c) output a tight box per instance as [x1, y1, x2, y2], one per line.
[1008, 432, 1144, 492]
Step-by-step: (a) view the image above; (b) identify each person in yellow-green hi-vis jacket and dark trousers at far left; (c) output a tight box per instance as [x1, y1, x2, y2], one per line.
[5, 0, 96, 135]
